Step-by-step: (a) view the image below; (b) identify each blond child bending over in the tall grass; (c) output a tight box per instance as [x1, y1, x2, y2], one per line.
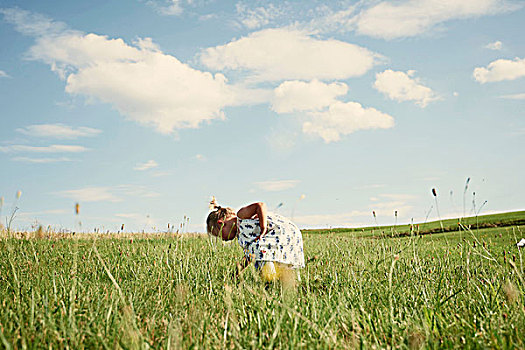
[206, 198, 304, 281]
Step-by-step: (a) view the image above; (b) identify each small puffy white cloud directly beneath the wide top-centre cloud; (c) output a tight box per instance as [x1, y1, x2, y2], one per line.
[272, 80, 348, 113]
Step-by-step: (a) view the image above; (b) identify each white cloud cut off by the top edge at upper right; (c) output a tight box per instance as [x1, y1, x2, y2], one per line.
[348, 0, 521, 40]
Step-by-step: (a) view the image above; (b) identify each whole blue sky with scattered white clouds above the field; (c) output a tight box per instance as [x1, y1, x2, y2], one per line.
[0, 0, 525, 232]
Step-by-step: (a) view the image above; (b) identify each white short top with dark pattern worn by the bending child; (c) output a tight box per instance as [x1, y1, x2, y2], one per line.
[237, 213, 304, 268]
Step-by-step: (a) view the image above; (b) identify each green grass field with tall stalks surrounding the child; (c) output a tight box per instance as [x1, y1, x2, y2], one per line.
[0, 212, 525, 349]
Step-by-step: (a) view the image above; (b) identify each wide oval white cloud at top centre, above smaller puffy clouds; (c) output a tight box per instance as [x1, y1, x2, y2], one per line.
[200, 28, 382, 81]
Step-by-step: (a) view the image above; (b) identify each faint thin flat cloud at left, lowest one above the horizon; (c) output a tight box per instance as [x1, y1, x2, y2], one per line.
[55, 185, 159, 202]
